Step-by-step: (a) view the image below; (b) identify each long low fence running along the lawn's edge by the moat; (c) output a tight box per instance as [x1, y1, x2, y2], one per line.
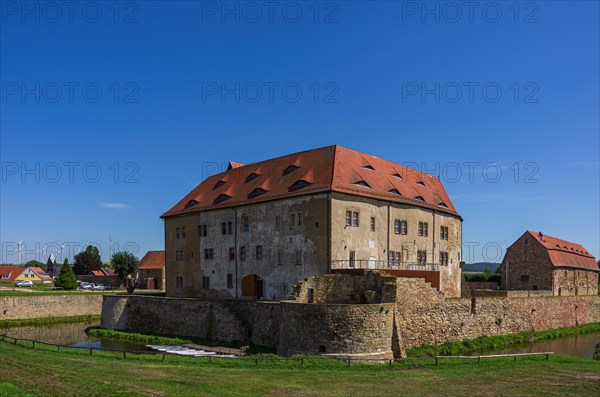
[0, 335, 554, 368]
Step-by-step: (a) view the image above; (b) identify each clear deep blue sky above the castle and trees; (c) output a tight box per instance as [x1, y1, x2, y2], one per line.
[0, 1, 600, 262]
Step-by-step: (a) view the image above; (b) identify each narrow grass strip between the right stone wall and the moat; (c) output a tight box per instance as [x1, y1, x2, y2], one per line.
[406, 323, 600, 357]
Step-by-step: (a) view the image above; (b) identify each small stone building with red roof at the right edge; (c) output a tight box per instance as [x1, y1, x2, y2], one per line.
[500, 231, 600, 295]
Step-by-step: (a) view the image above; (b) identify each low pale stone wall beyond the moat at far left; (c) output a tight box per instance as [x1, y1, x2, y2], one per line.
[0, 292, 102, 320]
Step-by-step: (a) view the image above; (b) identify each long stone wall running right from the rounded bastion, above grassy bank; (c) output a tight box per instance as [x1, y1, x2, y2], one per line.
[396, 278, 600, 349]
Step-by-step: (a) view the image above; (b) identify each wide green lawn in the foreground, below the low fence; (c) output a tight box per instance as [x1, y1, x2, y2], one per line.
[0, 342, 600, 397]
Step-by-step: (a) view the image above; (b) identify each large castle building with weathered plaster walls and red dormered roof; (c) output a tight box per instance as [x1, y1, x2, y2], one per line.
[161, 145, 462, 300]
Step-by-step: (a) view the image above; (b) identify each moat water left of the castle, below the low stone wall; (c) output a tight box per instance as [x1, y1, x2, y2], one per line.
[0, 322, 149, 351]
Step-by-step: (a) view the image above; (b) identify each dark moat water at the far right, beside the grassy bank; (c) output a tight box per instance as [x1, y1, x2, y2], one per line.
[473, 334, 600, 358]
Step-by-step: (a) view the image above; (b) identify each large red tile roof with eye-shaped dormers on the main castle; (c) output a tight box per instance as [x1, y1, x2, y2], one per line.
[161, 145, 458, 218]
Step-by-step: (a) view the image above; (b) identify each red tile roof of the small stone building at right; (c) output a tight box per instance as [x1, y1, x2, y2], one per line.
[527, 230, 600, 272]
